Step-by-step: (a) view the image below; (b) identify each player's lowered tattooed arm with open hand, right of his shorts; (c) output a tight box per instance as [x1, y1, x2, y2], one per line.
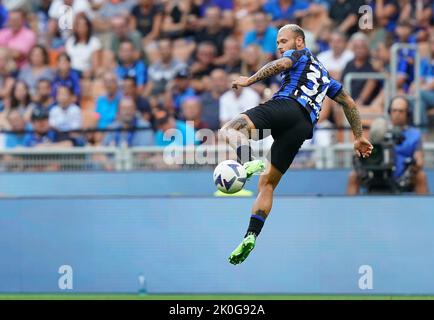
[333, 89, 374, 158]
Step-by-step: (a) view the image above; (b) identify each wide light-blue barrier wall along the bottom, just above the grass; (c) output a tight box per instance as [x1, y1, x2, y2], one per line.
[0, 194, 434, 294]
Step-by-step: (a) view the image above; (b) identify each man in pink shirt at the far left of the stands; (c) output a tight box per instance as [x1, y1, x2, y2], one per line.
[0, 10, 36, 67]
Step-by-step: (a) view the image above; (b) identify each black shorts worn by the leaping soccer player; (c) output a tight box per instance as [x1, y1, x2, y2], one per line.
[243, 99, 313, 174]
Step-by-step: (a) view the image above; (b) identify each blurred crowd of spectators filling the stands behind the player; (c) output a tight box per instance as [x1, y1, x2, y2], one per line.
[0, 0, 434, 148]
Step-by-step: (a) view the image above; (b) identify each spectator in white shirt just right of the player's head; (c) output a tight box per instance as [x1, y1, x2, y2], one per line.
[317, 31, 354, 80]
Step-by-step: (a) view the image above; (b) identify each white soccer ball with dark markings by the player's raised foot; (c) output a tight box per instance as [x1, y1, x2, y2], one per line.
[214, 160, 247, 194]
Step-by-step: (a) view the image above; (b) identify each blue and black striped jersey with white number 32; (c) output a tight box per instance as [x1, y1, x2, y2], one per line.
[273, 48, 342, 123]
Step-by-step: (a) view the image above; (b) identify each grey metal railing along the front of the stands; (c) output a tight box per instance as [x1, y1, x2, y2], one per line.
[0, 142, 434, 172]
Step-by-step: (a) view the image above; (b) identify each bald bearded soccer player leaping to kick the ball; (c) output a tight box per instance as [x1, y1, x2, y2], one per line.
[220, 24, 373, 264]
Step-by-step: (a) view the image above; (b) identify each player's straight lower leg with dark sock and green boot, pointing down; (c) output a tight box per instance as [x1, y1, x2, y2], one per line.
[229, 164, 282, 264]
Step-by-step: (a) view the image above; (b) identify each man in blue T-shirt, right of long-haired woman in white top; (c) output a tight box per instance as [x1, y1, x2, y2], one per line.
[117, 40, 148, 94]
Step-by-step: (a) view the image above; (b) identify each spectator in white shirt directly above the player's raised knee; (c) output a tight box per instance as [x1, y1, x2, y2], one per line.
[220, 74, 261, 126]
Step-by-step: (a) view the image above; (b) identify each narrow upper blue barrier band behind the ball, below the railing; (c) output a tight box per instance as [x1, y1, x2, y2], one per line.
[0, 170, 434, 196]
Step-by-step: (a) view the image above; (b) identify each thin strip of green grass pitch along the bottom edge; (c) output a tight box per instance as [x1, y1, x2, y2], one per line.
[0, 293, 434, 300]
